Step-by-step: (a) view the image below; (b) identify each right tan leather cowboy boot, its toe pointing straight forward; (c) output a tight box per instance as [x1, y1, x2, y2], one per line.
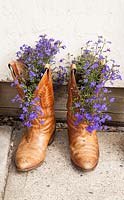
[67, 64, 99, 171]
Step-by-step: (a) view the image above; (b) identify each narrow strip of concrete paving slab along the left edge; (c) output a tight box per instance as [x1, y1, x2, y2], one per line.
[0, 126, 12, 200]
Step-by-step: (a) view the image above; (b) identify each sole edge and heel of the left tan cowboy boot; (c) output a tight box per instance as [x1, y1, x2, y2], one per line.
[15, 128, 56, 172]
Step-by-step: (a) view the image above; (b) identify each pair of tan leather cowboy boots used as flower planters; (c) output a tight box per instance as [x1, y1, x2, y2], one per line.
[9, 61, 99, 171]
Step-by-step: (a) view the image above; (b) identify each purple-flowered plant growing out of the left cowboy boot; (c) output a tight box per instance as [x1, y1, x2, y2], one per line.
[13, 35, 65, 127]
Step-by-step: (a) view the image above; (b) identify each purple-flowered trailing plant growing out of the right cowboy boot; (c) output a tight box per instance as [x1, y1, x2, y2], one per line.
[73, 36, 121, 132]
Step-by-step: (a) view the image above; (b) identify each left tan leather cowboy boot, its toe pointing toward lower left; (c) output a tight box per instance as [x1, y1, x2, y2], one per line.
[9, 61, 55, 171]
